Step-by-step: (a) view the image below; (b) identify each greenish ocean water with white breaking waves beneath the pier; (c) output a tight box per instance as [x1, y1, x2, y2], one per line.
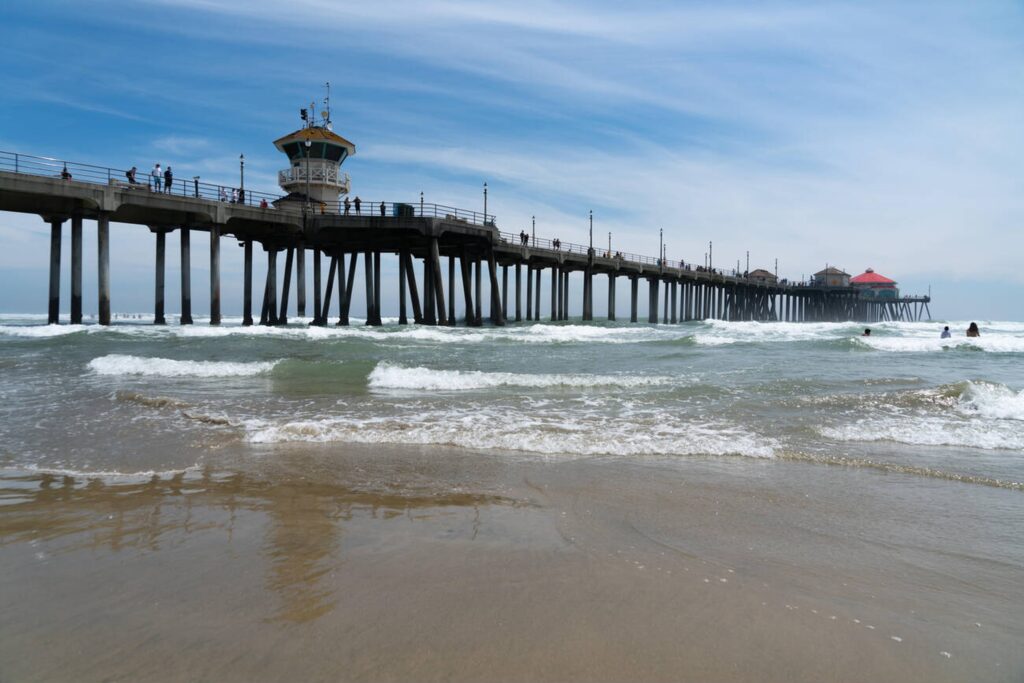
[0, 315, 1024, 490]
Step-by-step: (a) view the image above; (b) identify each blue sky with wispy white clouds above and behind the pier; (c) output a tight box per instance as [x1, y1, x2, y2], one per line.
[0, 0, 1024, 319]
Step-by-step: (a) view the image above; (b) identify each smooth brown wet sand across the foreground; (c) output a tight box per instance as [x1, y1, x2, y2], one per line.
[0, 445, 1024, 682]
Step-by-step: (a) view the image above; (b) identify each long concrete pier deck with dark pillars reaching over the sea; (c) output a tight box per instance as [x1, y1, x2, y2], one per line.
[0, 148, 931, 326]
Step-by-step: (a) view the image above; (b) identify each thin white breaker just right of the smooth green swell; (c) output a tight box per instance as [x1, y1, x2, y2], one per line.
[369, 362, 677, 391]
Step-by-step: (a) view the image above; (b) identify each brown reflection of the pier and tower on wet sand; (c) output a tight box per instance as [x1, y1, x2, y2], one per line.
[0, 469, 516, 623]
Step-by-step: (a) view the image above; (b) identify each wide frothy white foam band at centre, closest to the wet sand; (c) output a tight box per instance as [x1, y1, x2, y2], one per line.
[239, 407, 776, 458]
